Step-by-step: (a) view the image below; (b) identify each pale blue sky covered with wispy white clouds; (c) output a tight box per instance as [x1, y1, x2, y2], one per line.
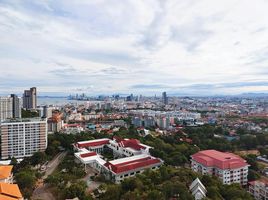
[0, 0, 268, 96]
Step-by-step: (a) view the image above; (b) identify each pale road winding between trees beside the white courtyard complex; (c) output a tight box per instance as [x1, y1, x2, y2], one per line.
[32, 152, 67, 200]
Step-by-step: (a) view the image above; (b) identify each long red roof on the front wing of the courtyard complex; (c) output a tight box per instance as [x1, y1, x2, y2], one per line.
[105, 157, 161, 174]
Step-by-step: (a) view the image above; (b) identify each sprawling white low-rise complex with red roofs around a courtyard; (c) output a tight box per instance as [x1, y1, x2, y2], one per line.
[74, 137, 163, 183]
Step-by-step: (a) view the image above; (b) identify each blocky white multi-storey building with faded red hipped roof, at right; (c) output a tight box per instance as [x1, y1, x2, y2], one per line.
[191, 150, 249, 185]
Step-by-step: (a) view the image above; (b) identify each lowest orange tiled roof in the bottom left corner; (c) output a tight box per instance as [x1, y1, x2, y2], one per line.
[0, 183, 22, 199]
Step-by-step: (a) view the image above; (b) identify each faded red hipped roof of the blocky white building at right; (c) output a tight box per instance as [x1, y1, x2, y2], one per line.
[192, 150, 248, 169]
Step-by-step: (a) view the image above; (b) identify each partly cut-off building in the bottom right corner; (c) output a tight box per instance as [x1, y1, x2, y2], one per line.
[248, 179, 268, 200]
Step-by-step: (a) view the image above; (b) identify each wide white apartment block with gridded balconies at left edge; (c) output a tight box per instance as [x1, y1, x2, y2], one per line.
[0, 118, 47, 159]
